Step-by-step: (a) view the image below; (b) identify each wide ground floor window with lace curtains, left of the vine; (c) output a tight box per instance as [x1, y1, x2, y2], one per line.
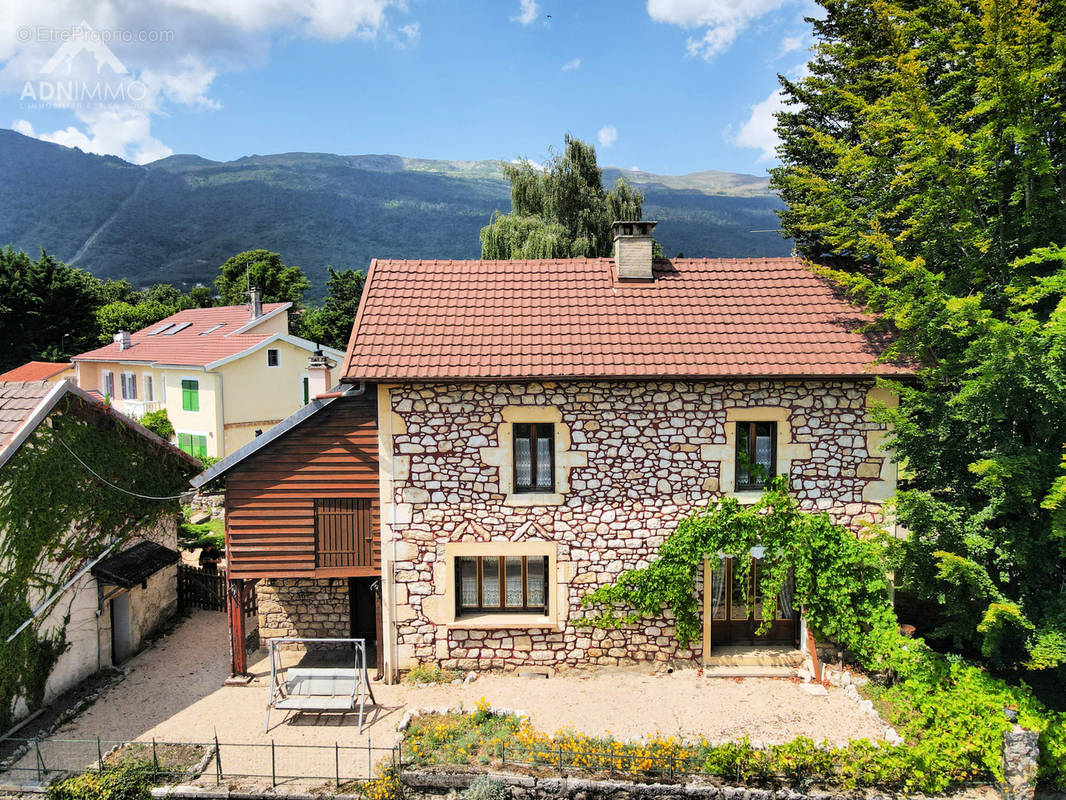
[455, 556, 548, 615]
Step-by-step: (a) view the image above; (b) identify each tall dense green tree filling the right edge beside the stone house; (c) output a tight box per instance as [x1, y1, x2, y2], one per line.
[773, 0, 1066, 668]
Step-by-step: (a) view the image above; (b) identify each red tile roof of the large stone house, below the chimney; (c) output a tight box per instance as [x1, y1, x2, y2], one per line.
[344, 258, 908, 381]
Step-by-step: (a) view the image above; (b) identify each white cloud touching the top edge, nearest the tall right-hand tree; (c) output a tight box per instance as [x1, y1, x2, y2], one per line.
[647, 0, 793, 60]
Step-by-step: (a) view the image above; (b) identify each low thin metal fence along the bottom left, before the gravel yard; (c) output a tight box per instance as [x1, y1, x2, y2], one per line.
[0, 738, 400, 786]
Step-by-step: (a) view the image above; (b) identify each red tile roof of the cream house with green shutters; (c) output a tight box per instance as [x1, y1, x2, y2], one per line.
[74, 303, 290, 367]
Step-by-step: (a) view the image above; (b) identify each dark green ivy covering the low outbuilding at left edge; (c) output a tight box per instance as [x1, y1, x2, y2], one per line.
[0, 397, 192, 732]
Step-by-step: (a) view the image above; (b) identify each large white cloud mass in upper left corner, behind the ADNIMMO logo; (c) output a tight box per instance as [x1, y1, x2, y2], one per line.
[0, 0, 411, 163]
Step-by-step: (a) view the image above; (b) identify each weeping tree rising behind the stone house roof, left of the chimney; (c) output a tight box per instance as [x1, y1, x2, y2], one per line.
[481, 133, 644, 258]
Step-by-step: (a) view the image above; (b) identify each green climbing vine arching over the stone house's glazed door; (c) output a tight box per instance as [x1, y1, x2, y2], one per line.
[578, 477, 898, 658]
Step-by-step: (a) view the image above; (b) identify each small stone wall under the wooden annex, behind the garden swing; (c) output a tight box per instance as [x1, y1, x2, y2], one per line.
[256, 578, 351, 642]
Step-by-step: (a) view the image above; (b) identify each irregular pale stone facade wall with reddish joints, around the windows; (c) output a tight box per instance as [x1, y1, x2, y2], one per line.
[378, 381, 894, 669]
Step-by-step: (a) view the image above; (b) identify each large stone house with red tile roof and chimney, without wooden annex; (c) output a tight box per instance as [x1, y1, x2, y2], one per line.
[197, 222, 905, 676]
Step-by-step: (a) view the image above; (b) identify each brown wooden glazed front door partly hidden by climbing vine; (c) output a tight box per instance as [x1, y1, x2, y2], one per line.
[707, 558, 800, 645]
